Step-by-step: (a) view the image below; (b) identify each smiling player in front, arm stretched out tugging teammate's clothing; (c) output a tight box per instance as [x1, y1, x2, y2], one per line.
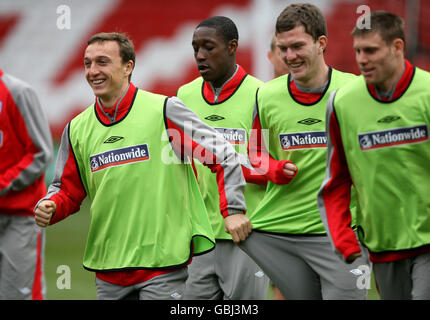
[35, 33, 249, 300]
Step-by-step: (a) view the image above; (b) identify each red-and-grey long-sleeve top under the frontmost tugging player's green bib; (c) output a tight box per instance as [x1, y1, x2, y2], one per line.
[41, 84, 249, 286]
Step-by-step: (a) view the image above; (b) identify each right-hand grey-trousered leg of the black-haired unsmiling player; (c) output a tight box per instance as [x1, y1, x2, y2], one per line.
[215, 240, 269, 300]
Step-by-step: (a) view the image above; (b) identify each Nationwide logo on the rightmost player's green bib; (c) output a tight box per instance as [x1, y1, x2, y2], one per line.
[358, 125, 429, 151]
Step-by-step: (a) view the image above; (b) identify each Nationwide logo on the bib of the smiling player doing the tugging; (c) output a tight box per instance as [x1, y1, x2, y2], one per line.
[90, 144, 149, 172]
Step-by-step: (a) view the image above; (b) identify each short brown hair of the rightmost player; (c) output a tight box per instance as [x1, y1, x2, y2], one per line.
[351, 10, 406, 44]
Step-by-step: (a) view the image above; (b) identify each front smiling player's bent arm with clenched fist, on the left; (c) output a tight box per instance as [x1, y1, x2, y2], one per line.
[34, 123, 87, 227]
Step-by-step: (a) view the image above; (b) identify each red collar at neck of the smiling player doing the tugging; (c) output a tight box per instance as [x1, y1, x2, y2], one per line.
[95, 82, 137, 125]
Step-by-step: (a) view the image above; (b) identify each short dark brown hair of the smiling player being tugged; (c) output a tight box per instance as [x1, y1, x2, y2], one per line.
[276, 3, 327, 41]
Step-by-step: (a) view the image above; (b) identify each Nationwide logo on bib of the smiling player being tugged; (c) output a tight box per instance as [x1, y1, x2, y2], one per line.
[279, 131, 327, 150]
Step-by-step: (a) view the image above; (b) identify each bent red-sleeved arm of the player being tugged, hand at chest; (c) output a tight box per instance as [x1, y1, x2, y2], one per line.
[248, 103, 297, 184]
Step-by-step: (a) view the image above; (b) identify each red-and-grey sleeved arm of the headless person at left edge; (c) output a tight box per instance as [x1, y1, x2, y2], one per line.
[0, 80, 53, 196]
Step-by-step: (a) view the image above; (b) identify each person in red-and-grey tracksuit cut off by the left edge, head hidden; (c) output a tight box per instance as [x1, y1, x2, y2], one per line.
[0, 70, 53, 300]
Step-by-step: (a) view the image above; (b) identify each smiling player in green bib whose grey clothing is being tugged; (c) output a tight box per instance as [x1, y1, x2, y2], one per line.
[240, 4, 367, 300]
